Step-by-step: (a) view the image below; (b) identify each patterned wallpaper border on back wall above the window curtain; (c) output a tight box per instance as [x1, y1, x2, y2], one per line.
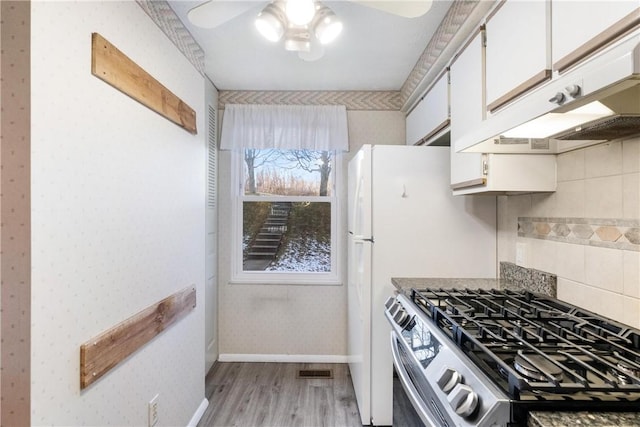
[218, 90, 401, 111]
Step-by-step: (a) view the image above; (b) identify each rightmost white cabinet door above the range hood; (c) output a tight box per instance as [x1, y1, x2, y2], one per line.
[551, 0, 640, 71]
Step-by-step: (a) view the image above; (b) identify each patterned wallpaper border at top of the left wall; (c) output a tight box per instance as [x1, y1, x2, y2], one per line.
[136, 0, 205, 76]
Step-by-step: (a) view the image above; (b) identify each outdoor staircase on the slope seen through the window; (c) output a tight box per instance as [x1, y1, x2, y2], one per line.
[247, 202, 291, 260]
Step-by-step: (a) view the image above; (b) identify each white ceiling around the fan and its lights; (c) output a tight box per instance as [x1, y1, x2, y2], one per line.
[169, 0, 452, 91]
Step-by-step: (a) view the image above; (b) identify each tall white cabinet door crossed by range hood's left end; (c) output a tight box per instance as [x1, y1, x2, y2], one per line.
[449, 31, 485, 187]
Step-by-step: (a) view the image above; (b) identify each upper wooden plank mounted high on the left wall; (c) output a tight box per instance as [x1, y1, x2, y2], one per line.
[91, 33, 197, 134]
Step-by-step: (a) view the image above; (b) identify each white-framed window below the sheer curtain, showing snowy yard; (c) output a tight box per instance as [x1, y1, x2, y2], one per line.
[232, 148, 339, 284]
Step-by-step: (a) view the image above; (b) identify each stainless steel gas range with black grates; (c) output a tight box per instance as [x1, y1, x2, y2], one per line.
[385, 289, 640, 426]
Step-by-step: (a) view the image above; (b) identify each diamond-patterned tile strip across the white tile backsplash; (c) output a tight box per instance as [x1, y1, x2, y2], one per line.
[518, 217, 640, 251]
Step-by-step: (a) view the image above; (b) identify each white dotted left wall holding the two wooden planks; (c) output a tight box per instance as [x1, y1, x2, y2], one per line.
[31, 1, 205, 426]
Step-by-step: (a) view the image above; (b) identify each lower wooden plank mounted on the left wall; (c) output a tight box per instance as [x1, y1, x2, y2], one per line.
[80, 287, 196, 390]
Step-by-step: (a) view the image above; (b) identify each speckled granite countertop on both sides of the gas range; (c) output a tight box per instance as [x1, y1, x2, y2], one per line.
[391, 271, 640, 427]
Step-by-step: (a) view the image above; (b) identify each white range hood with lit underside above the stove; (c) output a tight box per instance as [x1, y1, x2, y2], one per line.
[452, 30, 640, 154]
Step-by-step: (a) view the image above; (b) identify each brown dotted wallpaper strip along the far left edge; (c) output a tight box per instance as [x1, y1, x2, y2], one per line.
[0, 1, 31, 426]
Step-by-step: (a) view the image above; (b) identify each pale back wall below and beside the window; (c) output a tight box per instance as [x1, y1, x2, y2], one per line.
[218, 111, 405, 362]
